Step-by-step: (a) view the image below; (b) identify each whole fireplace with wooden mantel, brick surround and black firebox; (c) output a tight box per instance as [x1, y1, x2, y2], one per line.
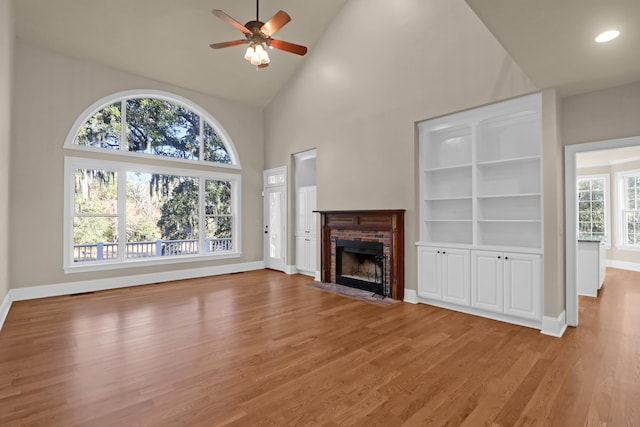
[317, 209, 404, 300]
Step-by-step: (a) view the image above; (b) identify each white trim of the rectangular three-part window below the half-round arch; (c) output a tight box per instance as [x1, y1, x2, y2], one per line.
[63, 156, 242, 273]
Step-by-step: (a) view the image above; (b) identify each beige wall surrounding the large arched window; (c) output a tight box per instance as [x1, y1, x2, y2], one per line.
[10, 43, 264, 288]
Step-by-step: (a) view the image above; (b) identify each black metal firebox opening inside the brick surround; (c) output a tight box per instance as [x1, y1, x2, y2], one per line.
[335, 240, 388, 297]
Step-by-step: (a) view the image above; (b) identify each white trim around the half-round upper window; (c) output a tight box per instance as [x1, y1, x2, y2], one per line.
[64, 89, 241, 169]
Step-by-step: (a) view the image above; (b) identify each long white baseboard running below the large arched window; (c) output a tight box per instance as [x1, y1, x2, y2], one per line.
[0, 261, 265, 329]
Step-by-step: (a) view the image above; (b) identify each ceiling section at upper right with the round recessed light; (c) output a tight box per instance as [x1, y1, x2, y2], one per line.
[465, 0, 640, 96]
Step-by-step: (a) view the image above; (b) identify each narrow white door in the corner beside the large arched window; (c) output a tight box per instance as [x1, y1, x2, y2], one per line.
[263, 166, 287, 271]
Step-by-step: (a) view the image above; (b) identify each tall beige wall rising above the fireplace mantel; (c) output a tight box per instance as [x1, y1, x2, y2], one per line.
[265, 0, 536, 298]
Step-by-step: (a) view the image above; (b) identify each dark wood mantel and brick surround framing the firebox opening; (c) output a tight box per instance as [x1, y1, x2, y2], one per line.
[318, 209, 405, 300]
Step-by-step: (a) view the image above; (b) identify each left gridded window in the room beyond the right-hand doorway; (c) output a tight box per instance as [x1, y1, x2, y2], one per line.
[578, 175, 609, 238]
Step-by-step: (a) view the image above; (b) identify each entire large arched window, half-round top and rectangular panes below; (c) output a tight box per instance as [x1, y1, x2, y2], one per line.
[64, 92, 241, 272]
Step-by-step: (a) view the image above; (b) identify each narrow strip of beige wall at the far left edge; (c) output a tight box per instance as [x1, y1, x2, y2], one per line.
[0, 0, 15, 304]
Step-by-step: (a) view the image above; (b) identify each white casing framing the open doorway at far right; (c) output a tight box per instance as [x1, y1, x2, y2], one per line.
[564, 136, 640, 326]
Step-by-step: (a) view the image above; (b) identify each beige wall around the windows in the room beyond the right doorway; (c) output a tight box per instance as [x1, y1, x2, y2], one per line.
[576, 161, 640, 264]
